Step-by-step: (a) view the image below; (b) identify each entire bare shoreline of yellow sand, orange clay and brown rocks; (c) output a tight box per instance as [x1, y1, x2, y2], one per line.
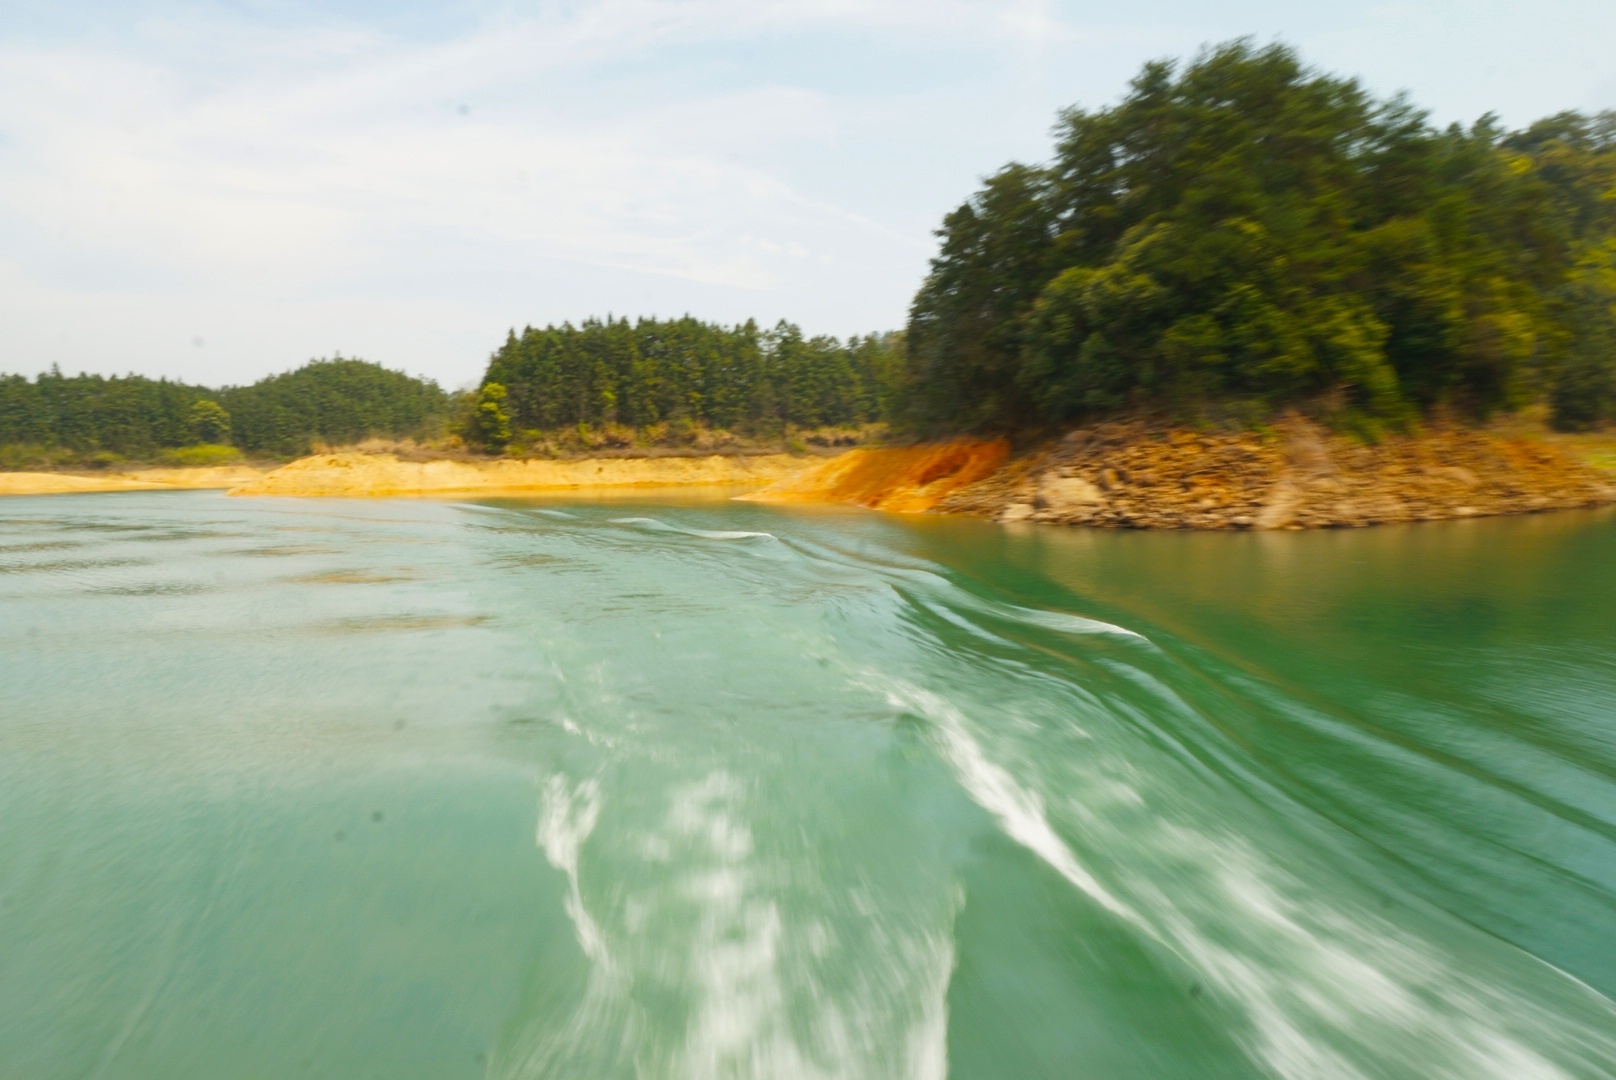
[0, 416, 1616, 530]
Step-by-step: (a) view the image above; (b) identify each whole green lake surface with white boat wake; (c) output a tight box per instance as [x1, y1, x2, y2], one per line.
[0, 493, 1616, 1080]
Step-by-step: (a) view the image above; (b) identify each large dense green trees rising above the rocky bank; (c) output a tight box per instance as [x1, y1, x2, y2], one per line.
[898, 42, 1616, 432]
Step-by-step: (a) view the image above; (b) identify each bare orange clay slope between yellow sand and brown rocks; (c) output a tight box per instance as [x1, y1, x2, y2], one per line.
[742, 438, 1010, 514]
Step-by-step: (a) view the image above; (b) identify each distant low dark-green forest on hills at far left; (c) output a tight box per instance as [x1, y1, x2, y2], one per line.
[0, 357, 449, 467]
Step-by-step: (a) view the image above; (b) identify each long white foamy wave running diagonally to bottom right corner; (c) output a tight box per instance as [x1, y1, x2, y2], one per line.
[863, 673, 1616, 1080]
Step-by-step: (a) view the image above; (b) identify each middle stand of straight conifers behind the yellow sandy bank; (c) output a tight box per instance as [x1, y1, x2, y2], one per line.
[473, 317, 898, 443]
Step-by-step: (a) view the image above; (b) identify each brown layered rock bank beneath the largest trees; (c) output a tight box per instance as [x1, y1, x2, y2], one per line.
[937, 419, 1616, 529]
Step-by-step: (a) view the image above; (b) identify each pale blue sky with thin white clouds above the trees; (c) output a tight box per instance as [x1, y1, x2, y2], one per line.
[0, 0, 1616, 388]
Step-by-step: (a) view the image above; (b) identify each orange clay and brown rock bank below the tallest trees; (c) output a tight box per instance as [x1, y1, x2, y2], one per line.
[743, 416, 1616, 530]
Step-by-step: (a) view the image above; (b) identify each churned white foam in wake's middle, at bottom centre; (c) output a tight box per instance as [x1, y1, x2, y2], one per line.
[517, 770, 963, 1080]
